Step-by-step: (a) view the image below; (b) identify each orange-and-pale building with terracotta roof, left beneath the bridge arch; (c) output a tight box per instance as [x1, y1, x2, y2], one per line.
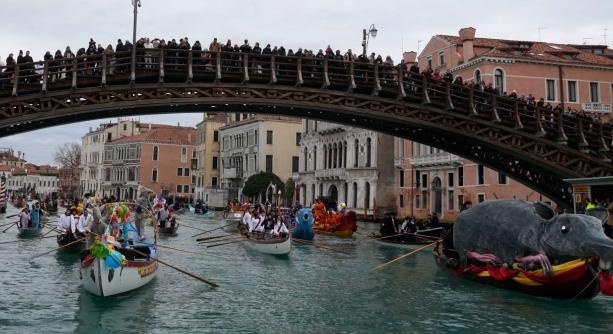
[102, 125, 196, 200]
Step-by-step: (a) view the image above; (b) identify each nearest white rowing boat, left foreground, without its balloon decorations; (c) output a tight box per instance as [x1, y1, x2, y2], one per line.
[81, 244, 159, 297]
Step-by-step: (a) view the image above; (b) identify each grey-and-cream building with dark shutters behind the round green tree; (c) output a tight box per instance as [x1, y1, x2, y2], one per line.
[220, 114, 302, 200]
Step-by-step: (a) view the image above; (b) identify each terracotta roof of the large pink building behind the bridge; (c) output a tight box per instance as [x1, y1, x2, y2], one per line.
[436, 35, 613, 66]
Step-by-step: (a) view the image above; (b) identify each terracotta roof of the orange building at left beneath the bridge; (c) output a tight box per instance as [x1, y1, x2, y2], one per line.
[111, 126, 196, 145]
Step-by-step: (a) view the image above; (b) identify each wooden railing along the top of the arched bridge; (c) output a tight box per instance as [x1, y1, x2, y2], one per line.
[0, 48, 613, 159]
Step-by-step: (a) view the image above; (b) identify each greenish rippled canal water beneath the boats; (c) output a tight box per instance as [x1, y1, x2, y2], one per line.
[0, 209, 613, 334]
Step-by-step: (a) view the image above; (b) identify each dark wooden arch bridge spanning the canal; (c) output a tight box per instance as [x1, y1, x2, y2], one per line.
[0, 49, 613, 206]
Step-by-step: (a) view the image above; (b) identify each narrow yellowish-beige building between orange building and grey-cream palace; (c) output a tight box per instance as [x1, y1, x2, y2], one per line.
[193, 113, 227, 207]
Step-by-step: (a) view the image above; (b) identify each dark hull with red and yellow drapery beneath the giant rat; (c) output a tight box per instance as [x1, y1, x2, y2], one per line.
[433, 241, 600, 299]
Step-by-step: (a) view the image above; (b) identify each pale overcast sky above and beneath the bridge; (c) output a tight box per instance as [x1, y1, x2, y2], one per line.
[0, 0, 613, 164]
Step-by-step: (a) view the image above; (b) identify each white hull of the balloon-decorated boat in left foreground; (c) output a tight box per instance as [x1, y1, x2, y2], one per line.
[81, 259, 159, 297]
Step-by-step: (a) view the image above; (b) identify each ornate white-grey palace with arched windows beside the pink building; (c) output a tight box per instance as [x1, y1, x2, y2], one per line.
[296, 120, 396, 217]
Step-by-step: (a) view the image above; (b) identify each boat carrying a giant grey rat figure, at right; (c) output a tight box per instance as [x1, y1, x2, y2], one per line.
[433, 200, 613, 299]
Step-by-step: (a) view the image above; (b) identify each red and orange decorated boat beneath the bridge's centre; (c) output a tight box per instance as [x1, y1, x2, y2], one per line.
[313, 208, 358, 238]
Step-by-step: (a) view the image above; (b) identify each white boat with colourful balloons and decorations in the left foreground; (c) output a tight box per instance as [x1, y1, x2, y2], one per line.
[81, 236, 159, 297]
